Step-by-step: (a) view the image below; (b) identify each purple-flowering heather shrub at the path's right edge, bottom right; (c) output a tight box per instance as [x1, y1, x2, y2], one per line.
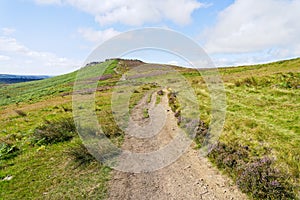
[208, 142, 295, 199]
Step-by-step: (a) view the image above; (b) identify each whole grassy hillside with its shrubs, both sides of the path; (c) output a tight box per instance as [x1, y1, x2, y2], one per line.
[0, 59, 300, 199]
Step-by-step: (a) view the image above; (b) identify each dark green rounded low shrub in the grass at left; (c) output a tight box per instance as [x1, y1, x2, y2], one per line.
[33, 118, 76, 145]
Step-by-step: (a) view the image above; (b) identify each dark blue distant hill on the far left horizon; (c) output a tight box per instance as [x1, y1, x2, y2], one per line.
[0, 74, 50, 84]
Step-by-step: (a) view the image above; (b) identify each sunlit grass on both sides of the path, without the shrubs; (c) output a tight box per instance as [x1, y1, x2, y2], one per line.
[0, 59, 300, 199]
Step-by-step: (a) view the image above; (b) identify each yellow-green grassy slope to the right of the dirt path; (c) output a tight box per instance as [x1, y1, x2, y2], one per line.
[189, 62, 300, 199]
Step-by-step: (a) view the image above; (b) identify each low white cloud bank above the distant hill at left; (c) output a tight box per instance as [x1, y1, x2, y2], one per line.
[0, 36, 81, 75]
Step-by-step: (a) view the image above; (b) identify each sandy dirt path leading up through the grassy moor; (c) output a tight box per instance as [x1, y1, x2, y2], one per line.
[109, 91, 247, 200]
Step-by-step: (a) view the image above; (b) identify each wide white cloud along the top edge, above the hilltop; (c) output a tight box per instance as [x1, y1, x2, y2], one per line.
[35, 0, 207, 26]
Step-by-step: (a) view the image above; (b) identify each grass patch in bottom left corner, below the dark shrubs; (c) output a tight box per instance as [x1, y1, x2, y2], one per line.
[0, 143, 110, 199]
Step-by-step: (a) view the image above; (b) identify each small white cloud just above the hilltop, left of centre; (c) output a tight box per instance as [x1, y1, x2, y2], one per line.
[78, 28, 120, 43]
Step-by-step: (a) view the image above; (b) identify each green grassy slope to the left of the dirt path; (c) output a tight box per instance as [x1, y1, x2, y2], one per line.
[0, 60, 122, 199]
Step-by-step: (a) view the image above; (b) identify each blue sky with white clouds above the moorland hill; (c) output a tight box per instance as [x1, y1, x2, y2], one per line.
[0, 0, 300, 75]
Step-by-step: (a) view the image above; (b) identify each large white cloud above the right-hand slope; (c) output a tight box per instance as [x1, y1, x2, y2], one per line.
[203, 0, 300, 54]
